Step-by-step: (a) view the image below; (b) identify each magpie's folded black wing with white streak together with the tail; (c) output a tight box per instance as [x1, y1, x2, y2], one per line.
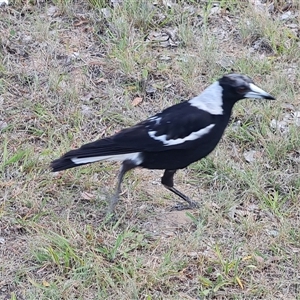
[52, 102, 217, 166]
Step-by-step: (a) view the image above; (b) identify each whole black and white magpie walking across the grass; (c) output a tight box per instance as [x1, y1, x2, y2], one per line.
[51, 74, 275, 213]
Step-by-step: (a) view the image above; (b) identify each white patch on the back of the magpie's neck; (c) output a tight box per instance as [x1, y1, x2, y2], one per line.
[188, 81, 223, 115]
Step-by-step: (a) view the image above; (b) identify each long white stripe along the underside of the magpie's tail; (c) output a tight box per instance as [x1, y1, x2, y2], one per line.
[71, 152, 143, 165]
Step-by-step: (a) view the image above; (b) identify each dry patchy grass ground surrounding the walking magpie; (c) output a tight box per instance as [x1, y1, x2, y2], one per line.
[0, 0, 300, 300]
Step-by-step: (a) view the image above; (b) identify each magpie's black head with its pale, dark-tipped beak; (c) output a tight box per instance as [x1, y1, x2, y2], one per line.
[219, 74, 275, 102]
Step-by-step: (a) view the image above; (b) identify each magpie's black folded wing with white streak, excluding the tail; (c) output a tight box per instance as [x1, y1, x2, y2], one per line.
[111, 102, 216, 152]
